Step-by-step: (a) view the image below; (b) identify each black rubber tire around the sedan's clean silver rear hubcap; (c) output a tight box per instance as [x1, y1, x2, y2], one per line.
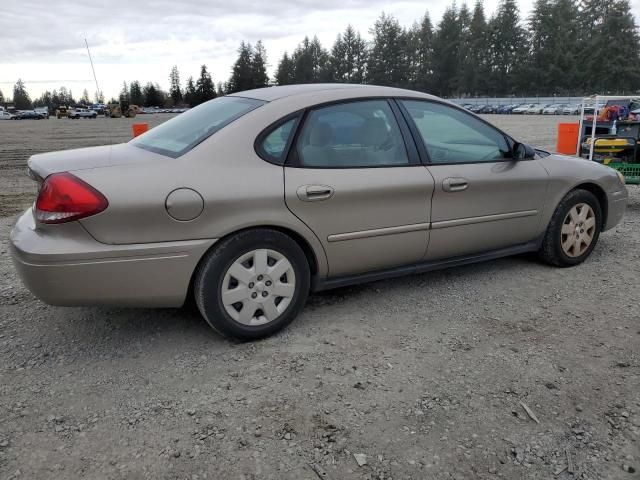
[194, 229, 310, 341]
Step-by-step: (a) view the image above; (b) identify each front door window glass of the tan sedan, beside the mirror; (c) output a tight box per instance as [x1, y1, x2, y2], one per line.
[402, 100, 511, 163]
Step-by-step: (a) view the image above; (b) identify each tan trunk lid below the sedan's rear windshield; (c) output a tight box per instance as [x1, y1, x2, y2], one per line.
[28, 143, 166, 179]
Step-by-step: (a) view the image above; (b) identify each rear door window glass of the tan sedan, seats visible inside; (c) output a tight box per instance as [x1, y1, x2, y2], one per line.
[296, 100, 409, 168]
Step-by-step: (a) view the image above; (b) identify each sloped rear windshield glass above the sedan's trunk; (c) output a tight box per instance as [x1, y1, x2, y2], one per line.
[129, 97, 266, 158]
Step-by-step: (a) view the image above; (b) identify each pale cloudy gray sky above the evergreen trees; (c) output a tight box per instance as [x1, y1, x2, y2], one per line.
[0, 0, 640, 99]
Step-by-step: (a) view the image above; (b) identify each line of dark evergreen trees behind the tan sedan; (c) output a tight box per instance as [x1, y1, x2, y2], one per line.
[0, 0, 640, 109]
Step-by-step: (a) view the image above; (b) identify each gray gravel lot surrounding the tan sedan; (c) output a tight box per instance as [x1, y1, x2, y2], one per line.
[0, 115, 640, 480]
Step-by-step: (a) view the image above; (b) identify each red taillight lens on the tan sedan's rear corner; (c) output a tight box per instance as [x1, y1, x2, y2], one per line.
[36, 172, 109, 223]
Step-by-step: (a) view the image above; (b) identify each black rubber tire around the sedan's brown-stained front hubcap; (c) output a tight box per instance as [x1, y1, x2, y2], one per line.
[547, 190, 603, 266]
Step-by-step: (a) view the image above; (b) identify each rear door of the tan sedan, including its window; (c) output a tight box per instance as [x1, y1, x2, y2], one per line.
[284, 98, 434, 277]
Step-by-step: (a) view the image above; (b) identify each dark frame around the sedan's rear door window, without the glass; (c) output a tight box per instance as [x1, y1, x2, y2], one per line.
[284, 96, 423, 170]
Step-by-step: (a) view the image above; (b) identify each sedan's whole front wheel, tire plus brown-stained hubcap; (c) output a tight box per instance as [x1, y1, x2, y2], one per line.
[538, 189, 602, 267]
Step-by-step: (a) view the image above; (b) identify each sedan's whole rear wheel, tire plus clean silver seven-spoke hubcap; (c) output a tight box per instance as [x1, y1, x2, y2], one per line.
[193, 229, 310, 341]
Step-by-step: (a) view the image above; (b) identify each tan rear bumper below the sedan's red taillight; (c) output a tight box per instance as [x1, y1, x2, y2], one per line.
[10, 209, 215, 307]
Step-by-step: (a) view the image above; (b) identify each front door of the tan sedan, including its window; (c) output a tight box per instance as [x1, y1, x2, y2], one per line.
[399, 100, 548, 260]
